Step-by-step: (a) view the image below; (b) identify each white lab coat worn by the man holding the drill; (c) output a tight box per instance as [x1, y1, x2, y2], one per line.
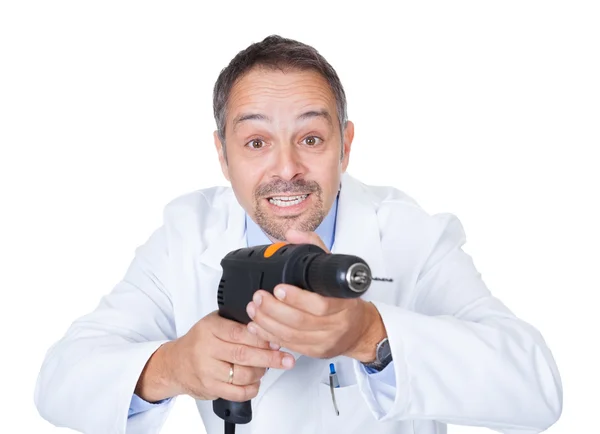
[35, 174, 562, 434]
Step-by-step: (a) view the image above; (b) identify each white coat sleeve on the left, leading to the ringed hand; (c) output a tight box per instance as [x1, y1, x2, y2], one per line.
[35, 226, 175, 434]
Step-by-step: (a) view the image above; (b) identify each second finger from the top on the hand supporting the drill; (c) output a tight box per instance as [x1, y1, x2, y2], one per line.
[246, 290, 322, 330]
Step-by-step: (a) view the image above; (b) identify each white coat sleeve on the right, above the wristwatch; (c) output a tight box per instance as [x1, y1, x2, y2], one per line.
[354, 214, 562, 434]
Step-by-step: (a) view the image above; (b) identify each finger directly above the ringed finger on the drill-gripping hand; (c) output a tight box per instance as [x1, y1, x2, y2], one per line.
[214, 342, 296, 375]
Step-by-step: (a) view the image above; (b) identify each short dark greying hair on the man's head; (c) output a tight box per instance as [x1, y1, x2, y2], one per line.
[213, 35, 348, 158]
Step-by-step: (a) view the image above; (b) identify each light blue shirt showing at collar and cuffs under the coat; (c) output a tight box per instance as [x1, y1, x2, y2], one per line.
[128, 195, 393, 417]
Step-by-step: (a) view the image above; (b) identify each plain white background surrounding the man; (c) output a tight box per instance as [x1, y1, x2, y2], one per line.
[0, 0, 600, 434]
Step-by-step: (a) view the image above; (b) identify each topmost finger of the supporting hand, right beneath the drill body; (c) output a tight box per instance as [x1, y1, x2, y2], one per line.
[270, 283, 344, 317]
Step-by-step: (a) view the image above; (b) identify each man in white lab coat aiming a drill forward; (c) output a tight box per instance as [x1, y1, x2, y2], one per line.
[35, 36, 562, 434]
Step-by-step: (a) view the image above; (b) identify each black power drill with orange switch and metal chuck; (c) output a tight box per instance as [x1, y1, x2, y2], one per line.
[213, 242, 390, 433]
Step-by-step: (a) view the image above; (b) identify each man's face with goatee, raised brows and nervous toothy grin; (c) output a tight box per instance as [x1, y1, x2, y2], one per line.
[214, 68, 354, 241]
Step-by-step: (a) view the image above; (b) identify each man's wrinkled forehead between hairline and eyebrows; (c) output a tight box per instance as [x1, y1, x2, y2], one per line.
[227, 68, 336, 120]
